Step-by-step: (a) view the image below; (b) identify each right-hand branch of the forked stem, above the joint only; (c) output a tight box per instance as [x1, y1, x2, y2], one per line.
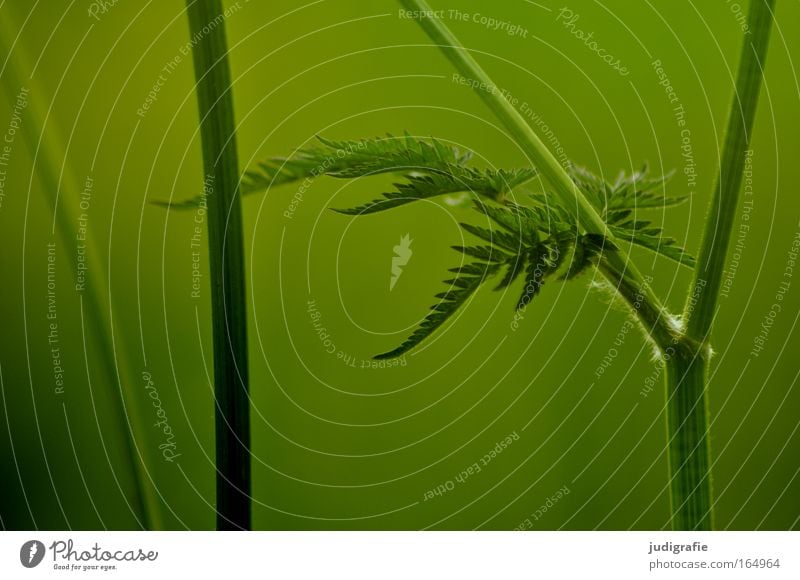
[685, 0, 775, 341]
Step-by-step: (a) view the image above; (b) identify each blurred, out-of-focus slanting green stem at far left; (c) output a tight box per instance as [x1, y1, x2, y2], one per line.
[0, 13, 162, 530]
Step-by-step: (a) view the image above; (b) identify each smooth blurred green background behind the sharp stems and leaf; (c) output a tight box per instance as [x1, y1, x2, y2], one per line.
[0, 0, 800, 529]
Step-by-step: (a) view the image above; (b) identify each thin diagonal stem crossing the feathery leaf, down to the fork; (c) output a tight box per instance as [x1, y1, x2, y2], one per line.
[398, 0, 669, 348]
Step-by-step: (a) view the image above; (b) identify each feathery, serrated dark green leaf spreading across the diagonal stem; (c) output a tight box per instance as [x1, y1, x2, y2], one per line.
[242, 134, 695, 359]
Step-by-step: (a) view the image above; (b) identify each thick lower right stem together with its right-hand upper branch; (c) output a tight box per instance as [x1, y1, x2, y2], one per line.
[665, 0, 775, 530]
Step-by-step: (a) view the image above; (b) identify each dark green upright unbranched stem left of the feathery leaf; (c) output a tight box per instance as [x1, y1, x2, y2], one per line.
[186, 0, 251, 530]
